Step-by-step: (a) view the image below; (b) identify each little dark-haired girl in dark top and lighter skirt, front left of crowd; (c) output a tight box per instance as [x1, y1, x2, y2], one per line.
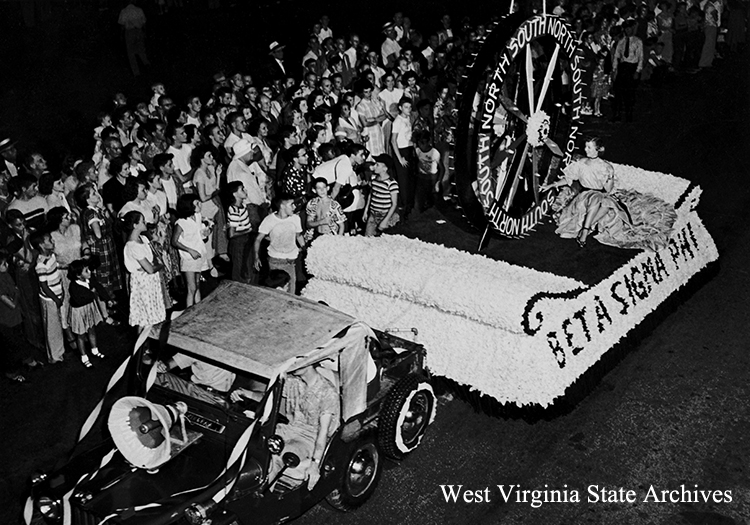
[68, 259, 109, 368]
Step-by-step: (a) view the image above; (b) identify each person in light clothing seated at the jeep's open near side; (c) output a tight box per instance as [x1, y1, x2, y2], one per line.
[258, 364, 340, 490]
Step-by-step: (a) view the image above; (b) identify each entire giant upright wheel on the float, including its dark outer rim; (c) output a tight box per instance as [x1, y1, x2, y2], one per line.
[453, 14, 583, 238]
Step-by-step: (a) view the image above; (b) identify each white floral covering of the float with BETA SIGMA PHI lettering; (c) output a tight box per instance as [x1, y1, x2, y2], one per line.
[305, 166, 718, 406]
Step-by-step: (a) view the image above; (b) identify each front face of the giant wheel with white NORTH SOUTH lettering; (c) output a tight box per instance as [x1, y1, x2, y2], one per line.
[474, 16, 583, 237]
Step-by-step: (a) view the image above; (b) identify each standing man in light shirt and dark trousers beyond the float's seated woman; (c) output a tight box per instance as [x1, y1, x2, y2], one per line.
[612, 20, 643, 122]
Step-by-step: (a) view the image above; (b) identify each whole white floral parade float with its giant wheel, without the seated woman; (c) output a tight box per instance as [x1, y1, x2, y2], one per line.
[304, 10, 718, 415]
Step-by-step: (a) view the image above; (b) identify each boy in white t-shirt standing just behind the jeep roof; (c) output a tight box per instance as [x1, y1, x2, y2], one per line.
[253, 195, 305, 294]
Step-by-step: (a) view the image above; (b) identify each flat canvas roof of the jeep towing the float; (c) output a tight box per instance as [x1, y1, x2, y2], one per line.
[151, 281, 356, 377]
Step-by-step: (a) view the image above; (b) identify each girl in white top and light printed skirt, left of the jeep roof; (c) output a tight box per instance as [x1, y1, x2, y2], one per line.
[123, 210, 167, 326]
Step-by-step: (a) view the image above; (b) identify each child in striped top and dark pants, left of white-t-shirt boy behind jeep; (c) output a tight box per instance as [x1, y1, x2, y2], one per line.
[226, 181, 258, 284]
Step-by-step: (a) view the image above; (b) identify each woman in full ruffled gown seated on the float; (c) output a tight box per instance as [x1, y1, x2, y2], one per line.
[541, 137, 677, 251]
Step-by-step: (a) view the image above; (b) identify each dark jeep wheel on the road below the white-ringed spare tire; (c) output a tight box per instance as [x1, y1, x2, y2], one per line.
[326, 432, 383, 512]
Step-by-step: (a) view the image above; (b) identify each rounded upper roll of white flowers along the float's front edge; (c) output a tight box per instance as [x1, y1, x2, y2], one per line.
[306, 235, 582, 332]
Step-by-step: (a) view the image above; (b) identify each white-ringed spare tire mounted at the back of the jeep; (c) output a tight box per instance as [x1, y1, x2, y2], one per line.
[378, 374, 437, 459]
